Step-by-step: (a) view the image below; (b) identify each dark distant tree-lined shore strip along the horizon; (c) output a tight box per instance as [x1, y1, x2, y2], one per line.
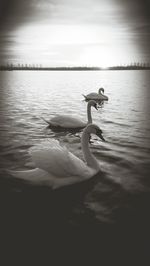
[0, 66, 150, 71]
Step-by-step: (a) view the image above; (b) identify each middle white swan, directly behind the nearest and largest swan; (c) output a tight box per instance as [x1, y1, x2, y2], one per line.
[43, 100, 98, 129]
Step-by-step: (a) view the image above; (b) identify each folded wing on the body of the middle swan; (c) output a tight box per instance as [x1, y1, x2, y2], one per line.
[49, 115, 87, 128]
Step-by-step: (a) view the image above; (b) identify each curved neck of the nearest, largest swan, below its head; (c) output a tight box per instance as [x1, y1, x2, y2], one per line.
[81, 131, 99, 170]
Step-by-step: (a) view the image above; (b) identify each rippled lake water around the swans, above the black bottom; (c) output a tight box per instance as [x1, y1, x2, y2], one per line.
[0, 70, 150, 231]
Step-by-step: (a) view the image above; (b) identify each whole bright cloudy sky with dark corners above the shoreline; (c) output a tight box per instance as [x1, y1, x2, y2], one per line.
[0, 0, 150, 67]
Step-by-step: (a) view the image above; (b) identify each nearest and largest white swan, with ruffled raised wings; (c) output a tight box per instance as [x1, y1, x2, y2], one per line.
[7, 124, 105, 189]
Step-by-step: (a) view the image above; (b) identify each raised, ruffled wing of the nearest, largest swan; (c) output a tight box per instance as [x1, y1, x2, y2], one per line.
[30, 139, 91, 178]
